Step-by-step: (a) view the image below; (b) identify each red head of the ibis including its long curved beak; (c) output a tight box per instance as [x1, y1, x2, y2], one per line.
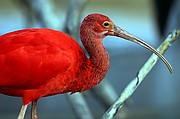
[80, 14, 173, 73]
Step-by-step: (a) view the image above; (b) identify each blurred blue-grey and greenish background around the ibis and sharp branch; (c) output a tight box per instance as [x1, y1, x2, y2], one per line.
[0, 0, 180, 119]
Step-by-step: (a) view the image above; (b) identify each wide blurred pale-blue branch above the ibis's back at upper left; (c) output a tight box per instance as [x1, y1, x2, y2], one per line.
[18, 0, 59, 29]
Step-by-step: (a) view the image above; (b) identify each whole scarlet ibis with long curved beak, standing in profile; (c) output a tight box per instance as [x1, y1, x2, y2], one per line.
[0, 14, 173, 118]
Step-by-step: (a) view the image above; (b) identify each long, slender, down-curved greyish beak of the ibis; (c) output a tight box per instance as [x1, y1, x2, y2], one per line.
[113, 26, 173, 74]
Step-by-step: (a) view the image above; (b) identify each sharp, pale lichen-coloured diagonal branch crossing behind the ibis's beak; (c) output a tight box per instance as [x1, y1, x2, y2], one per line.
[102, 30, 180, 119]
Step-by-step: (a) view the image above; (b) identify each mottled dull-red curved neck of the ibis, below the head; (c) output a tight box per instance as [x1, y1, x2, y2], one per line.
[81, 34, 110, 91]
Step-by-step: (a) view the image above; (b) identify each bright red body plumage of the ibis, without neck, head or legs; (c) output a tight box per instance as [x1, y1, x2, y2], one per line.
[0, 28, 92, 105]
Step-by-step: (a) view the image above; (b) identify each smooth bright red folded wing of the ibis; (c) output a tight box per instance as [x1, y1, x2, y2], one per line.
[0, 29, 84, 89]
